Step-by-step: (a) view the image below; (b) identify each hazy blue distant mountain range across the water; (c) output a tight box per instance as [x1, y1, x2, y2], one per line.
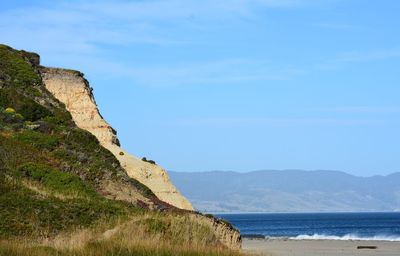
[169, 170, 400, 212]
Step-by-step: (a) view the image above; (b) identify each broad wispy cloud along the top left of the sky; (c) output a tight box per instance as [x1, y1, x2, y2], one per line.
[0, 0, 310, 52]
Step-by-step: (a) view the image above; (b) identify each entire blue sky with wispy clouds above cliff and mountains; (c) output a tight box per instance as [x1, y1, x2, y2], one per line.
[0, 0, 400, 176]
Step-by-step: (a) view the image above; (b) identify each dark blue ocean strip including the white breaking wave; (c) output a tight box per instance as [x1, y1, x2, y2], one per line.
[217, 213, 400, 241]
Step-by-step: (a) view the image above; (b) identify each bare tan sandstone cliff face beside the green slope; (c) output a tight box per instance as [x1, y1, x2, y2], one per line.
[41, 68, 193, 210]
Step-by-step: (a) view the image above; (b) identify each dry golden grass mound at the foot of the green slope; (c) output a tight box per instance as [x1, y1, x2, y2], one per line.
[0, 212, 242, 256]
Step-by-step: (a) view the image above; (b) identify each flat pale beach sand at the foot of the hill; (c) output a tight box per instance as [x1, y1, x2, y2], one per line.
[242, 238, 400, 256]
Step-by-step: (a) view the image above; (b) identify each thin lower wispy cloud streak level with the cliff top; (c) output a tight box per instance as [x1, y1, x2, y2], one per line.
[71, 59, 303, 87]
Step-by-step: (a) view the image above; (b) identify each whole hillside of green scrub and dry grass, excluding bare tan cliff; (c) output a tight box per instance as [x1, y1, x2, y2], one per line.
[0, 45, 240, 255]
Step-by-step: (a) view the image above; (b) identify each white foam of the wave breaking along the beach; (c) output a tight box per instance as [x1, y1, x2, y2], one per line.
[288, 234, 400, 242]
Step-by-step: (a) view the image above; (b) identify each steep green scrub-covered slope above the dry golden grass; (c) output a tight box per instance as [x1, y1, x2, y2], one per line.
[0, 45, 159, 238]
